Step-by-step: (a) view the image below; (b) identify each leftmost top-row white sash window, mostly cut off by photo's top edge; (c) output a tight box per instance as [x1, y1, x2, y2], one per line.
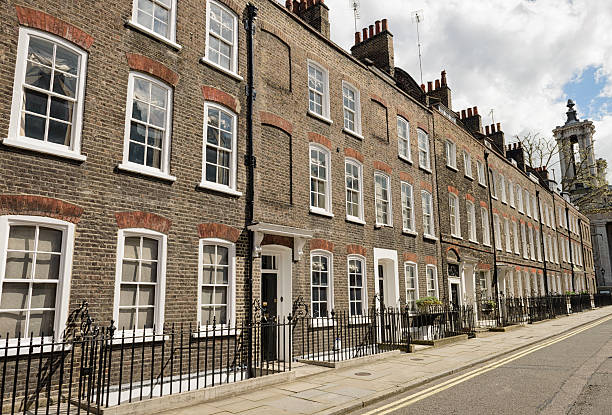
[131, 0, 176, 42]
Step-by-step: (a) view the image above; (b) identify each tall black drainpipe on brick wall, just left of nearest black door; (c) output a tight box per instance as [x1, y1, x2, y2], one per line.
[244, 3, 257, 377]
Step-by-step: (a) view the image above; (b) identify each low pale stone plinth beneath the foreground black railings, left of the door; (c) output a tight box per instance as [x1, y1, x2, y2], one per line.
[96, 371, 296, 415]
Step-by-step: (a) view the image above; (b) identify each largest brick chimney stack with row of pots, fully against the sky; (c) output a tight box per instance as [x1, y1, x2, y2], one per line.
[351, 19, 395, 76]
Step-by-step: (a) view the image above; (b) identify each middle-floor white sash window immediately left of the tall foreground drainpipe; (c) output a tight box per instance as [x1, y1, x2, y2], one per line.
[200, 102, 236, 193]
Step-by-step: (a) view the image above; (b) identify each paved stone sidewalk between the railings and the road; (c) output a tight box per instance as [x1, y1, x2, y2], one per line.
[161, 307, 612, 415]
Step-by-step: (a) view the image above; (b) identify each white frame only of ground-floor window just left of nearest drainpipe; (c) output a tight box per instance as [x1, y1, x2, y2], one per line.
[197, 238, 236, 330]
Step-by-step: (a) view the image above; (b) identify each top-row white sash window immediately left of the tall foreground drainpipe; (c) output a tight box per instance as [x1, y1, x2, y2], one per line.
[203, 0, 238, 74]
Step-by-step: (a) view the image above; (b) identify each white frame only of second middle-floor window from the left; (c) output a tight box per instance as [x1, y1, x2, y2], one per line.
[118, 72, 176, 181]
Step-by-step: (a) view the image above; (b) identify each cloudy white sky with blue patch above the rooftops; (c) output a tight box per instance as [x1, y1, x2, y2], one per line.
[290, 0, 612, 183]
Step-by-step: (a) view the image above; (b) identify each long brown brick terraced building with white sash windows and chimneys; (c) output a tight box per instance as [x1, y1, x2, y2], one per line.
[0, 0, 594, 354]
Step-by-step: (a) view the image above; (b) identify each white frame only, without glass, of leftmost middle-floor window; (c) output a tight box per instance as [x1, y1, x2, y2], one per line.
[2, 27, 88, 161]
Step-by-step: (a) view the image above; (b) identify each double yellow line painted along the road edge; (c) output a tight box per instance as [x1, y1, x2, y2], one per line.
[363, 315, 612, 415]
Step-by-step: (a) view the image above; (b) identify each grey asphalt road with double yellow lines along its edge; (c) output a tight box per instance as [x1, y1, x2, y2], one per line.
[355, 320, 612, 415]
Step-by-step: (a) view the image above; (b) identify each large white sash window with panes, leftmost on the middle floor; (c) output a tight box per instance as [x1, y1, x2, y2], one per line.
[3, 27, 87, 160]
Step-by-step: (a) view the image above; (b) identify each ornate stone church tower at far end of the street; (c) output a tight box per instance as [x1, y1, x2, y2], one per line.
[553, 99, 598, 196]
